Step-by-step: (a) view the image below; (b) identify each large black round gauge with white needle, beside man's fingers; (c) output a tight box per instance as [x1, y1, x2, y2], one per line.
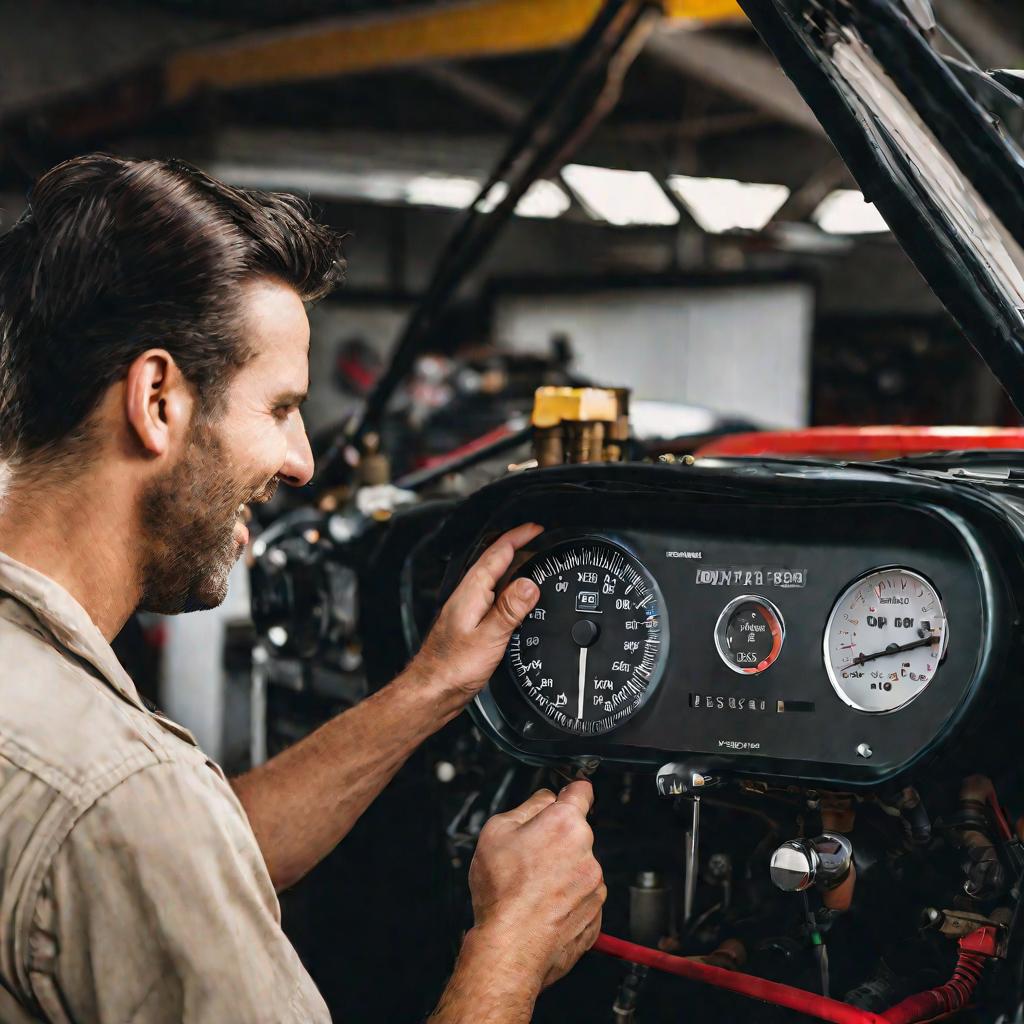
[508, 538, 668, 735]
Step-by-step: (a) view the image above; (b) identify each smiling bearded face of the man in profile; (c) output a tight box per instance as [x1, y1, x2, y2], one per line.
[140, 279, 313, 614]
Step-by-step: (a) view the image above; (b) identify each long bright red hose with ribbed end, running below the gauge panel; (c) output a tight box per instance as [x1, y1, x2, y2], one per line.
[594, 927, 996, 1024]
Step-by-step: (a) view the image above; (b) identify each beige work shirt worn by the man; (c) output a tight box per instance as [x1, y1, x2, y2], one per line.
[0, 553, 330, 1024]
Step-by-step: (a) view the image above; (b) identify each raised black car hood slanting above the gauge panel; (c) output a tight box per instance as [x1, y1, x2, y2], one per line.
[739, 0, 1024, 412]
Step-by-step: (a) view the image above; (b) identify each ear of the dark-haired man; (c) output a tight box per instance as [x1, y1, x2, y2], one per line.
[124, 348, 195, 456]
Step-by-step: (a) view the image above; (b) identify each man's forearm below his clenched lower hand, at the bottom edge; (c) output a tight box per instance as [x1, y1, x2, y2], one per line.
[427, 928, 540, 1024]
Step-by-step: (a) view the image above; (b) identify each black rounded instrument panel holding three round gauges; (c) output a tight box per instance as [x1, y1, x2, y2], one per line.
[436, 466, 1019, 786]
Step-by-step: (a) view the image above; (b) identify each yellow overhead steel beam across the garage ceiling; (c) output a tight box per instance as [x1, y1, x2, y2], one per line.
[165, 0, 742, 102]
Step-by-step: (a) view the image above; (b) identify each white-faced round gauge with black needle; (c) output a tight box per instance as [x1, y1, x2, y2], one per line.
[824, 568, 949, 714]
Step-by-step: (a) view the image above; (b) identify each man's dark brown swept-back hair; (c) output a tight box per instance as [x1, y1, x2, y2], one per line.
[0, 154, 344, 460]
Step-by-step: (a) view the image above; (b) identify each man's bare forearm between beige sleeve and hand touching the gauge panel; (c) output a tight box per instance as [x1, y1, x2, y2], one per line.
[231, 663, 464, 890]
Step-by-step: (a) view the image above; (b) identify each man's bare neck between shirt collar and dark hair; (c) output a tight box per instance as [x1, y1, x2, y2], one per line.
[0, 467, 140, 641]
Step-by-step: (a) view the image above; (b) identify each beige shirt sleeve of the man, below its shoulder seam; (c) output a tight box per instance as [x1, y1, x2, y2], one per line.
[30, 763, 330, 1024]
